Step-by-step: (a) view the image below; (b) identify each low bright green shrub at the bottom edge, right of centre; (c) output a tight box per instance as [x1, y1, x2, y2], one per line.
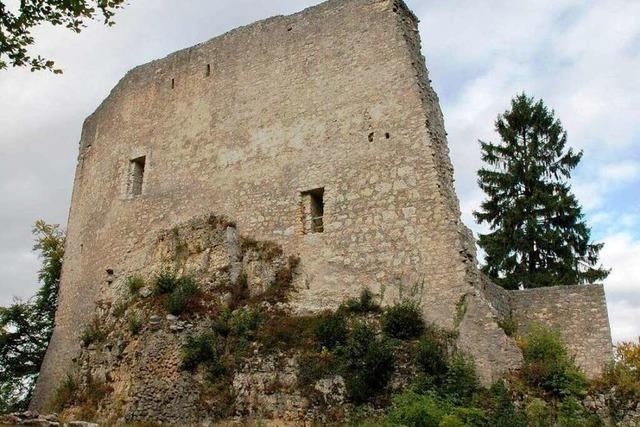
[387, 391, 450, 427]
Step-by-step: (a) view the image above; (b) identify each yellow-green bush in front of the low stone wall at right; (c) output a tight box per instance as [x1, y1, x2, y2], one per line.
[521, 325, 587, 397]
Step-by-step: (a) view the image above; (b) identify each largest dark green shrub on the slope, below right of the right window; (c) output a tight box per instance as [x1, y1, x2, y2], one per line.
[337, 322, 395, 403]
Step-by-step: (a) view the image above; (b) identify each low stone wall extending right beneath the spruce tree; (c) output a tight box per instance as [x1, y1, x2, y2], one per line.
[509, 285, 613, 377]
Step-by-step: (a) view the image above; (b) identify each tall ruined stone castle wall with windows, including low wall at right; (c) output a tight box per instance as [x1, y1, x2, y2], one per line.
[32, 0, 611, 408]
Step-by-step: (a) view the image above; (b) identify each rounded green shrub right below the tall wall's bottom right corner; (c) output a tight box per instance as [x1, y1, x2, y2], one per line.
[440, 353, 479, 404]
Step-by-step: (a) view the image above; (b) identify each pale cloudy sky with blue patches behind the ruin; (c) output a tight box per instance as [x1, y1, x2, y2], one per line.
[0, 0, 640, 340]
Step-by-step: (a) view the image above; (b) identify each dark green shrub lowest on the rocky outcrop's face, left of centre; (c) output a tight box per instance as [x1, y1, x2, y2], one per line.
[181, 331, 226, 378]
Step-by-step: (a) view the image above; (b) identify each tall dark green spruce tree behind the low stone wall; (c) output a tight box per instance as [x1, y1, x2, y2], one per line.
[474, 93, 609, 289]
